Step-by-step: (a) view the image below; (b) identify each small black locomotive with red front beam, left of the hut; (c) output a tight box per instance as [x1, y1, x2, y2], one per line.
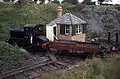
[7, 24, 50, 50]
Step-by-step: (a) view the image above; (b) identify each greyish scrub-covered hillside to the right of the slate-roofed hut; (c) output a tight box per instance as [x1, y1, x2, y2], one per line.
[72, 5, 120, 37]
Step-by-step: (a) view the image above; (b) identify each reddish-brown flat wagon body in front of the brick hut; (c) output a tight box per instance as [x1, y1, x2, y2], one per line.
[51, 40, 100, 53]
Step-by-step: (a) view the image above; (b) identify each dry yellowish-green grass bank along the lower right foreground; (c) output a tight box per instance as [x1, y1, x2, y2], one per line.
[40, 55, 120, 79]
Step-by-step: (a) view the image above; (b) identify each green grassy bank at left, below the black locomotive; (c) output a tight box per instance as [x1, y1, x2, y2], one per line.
[0, 42, 30, 71]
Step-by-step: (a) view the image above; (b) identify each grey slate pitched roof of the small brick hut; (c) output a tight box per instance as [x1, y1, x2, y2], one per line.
[47, 13, 86, 26]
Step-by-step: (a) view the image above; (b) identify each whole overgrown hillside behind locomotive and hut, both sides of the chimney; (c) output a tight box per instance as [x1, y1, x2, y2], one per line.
[0, 3, 120, 40]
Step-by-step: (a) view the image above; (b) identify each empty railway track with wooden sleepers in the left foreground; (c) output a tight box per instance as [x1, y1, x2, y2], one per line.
[0, 55, 68, 79]
